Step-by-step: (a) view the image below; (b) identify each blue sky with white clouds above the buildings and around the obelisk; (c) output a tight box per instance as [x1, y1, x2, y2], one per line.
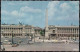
[1, 1, 79, 28]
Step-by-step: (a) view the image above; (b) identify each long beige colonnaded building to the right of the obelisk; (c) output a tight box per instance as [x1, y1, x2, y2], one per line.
[48, 25, 79, 39]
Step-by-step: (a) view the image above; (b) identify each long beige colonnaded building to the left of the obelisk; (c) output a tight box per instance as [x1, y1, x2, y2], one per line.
[1, 25, 34, 37]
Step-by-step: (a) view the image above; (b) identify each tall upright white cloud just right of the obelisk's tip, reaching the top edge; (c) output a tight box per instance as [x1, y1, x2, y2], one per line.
[47, 1, 59, 19]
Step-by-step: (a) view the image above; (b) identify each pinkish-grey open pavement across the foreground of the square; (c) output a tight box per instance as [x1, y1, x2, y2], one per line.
[4, 42, 79, 51]
